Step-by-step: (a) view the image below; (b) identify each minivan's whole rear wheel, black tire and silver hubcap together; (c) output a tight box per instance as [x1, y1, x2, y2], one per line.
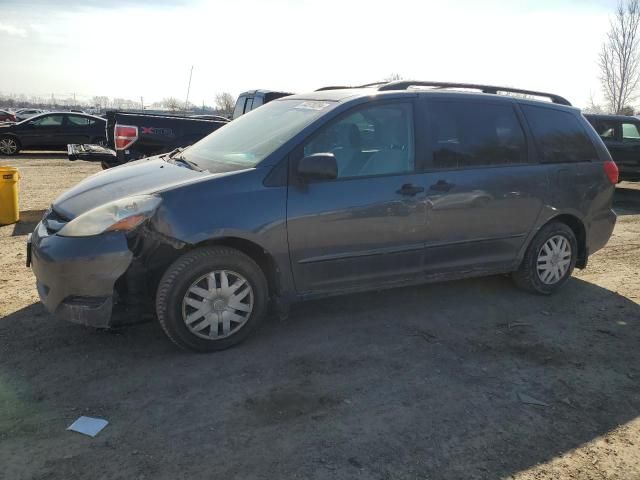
[513, 222, 578, 295]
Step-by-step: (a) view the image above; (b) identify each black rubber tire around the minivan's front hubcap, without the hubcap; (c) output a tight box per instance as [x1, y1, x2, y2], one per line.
[156, 247, 269, 352]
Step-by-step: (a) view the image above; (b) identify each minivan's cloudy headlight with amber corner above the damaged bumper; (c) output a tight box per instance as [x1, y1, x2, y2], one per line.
[58, 195, 161, 237]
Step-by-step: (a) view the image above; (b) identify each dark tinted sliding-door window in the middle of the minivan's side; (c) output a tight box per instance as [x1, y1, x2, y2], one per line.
[429, 101, 527, 169]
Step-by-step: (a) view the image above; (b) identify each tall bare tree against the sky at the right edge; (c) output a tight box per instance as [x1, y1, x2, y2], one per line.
[598, 0, 640, 114]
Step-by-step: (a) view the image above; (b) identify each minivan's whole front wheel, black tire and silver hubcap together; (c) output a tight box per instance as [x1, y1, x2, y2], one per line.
[156, 247, 268, 352]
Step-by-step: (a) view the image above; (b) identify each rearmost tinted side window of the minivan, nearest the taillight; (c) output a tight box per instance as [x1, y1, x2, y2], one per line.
[522, 105, 598, 163]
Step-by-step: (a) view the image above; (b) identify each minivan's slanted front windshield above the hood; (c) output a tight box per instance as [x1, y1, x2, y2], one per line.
[180, 100, 336, 172]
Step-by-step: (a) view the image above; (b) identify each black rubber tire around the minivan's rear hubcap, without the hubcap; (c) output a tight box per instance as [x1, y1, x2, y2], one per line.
[512, 222, 578, 295]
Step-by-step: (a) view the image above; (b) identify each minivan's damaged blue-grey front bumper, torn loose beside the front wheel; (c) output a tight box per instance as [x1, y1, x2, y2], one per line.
[30, 222, 133, 328]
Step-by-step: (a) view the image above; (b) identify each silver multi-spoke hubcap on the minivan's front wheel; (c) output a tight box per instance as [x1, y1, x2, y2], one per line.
[182, 270, 253, 340]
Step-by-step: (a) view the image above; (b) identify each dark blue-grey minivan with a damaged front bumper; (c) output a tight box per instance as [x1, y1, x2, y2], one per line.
[28, 81, 618, 351]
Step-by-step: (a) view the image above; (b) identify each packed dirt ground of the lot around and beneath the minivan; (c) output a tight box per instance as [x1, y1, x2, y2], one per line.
[0, 153, 640, 480]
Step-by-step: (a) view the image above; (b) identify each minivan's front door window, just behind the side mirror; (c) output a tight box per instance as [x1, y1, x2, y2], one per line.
[304, 103, 415, 178]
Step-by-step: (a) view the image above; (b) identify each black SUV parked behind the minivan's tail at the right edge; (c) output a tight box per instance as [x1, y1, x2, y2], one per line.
[585, 115, 640, 181]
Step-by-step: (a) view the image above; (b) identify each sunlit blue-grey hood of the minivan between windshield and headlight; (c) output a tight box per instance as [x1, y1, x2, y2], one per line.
[52, 157, 211, 220]
